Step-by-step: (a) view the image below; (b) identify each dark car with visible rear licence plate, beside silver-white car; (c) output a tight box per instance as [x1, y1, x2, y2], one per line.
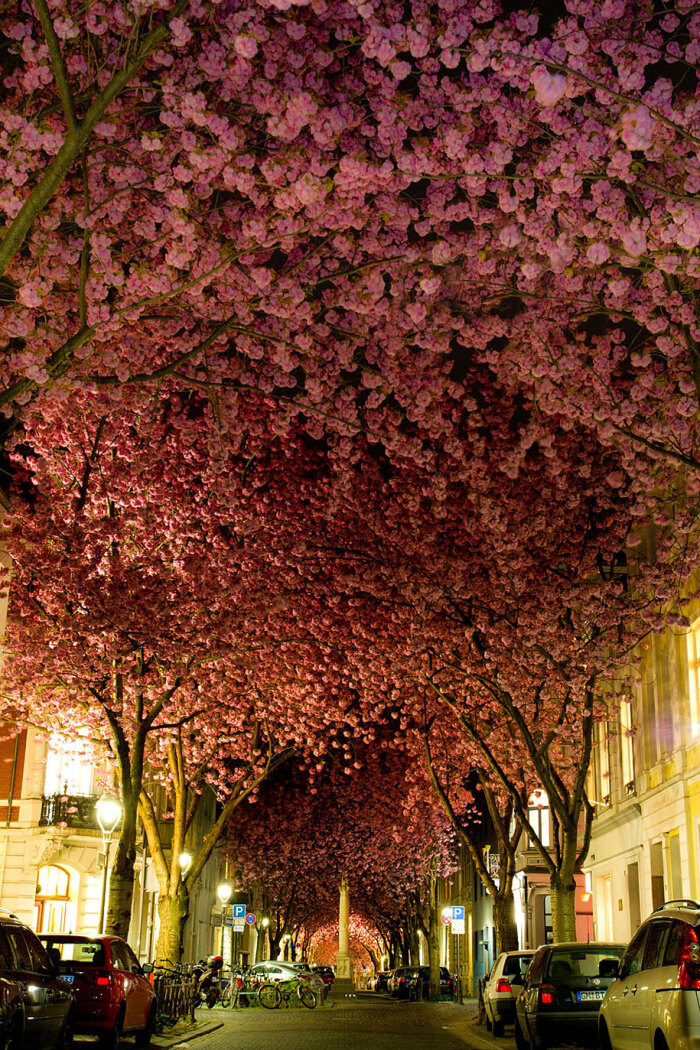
[514, 941, 625, 1050]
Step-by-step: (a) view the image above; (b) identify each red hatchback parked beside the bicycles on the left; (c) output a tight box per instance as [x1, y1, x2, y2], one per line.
[41, 933, 155, 1050]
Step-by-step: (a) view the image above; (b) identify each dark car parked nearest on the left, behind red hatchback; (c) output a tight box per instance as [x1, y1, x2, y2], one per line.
[0, 911, 75, 1050]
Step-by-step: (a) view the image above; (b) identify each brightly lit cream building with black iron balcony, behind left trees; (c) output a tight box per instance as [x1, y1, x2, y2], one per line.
[0, 729, 222, 962]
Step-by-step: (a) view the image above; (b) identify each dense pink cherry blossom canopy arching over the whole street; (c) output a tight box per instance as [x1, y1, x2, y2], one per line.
[0, 0, 700, 940]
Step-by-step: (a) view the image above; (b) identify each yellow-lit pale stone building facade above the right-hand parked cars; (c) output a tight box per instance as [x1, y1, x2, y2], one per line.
[586, 617, 700, 941]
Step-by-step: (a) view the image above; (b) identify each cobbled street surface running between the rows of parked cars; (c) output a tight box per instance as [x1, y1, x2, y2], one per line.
[144, 994, 514, 1050]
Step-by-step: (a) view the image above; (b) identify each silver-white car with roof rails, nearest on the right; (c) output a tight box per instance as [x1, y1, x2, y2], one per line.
[598, 900, 700, 1050]
